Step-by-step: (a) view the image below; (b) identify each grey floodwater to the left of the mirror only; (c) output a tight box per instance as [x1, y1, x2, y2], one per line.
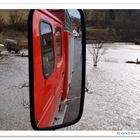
[0, 51, 31, 130]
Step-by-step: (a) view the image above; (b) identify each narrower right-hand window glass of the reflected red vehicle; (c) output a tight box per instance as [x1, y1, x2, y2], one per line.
[56, 27, 62, 62]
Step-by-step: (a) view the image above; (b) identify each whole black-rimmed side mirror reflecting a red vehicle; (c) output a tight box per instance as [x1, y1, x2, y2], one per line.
[28, 10, 86, 130]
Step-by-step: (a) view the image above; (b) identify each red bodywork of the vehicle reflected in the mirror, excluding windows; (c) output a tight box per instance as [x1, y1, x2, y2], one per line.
[33, 10, 72, 128]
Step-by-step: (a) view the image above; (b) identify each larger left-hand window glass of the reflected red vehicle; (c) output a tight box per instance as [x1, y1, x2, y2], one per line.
[40, 22, 54, 78]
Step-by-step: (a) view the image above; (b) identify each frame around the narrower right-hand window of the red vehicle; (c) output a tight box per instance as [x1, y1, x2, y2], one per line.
[55, 26, 63, 63]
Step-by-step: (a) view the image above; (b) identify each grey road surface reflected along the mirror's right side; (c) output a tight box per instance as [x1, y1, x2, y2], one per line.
[64, 38, 82, 123]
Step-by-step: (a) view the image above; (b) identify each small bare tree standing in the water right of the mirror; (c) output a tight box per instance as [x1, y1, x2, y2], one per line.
[89, 41, 106, 67]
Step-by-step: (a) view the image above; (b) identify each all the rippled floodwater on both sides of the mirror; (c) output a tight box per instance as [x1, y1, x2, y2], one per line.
[0, 43, 140, 130]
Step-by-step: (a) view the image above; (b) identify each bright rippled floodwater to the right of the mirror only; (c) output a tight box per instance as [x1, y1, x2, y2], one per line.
[66, 43, 140, 130]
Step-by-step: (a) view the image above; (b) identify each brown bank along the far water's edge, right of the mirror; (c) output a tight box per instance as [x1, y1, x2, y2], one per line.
[86, 27, 140, 45]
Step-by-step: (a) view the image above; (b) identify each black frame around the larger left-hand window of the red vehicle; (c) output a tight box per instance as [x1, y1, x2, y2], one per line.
[39, 19, 55, 80]
